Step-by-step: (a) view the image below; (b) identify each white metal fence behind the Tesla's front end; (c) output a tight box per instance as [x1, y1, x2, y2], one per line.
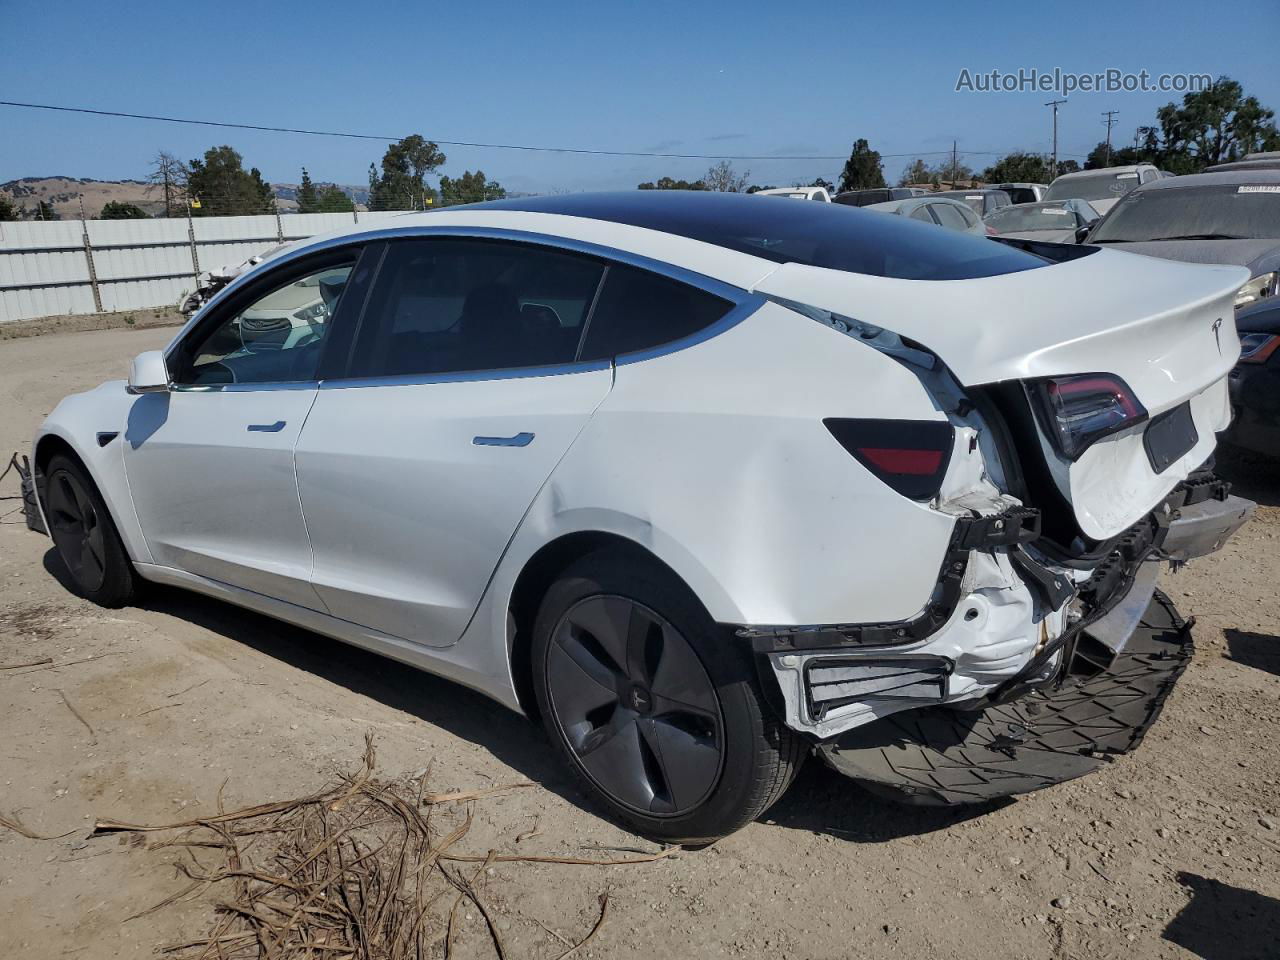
[0, 211, 409, 323]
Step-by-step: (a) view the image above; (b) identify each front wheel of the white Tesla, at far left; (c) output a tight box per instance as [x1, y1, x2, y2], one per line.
[42, 453, 136, 607]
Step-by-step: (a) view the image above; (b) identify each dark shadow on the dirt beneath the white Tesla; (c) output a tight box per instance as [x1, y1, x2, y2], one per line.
[44, 549, 998, 844]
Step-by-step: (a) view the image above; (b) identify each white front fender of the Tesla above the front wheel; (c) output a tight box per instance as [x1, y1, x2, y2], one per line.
[32, 380, 151, 563]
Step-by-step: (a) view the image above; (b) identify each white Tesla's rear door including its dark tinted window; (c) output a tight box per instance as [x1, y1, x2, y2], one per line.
[297, 238, 612, 645]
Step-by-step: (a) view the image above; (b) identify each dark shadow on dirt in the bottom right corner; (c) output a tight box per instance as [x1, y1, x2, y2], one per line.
[1162, 873, 1280, 960]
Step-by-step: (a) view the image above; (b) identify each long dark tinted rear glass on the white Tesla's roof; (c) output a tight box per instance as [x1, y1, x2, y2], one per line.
[483, 191, 1051, 280]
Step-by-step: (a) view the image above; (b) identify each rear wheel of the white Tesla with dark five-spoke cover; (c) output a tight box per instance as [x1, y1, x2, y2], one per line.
[532, 549, 804, 844]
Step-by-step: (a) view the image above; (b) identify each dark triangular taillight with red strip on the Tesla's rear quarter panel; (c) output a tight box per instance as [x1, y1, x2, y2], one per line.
[822, 417, 955, 500]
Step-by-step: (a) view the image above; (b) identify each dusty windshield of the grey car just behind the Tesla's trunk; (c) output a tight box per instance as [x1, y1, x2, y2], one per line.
[1089, 183, 1280, 243]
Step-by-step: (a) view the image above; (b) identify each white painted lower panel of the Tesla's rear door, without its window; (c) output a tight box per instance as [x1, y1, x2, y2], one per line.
[297, 364, 612, 646]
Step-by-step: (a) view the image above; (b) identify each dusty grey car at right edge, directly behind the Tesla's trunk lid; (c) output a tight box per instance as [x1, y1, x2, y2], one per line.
[1083, 169, 1280, 308]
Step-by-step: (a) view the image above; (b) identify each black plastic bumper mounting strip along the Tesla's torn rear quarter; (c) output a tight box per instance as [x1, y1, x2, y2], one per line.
[736, 507, 1039, 653]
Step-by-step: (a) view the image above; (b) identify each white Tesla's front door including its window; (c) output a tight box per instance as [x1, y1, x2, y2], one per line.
[124, 251, 366, 609]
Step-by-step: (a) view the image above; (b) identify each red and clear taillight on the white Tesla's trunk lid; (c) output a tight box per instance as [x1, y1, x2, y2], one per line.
[1029, 374, 1147, 461]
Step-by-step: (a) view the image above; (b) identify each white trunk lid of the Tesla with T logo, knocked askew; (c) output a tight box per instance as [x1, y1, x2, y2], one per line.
[755, 250, 1248, 540]
